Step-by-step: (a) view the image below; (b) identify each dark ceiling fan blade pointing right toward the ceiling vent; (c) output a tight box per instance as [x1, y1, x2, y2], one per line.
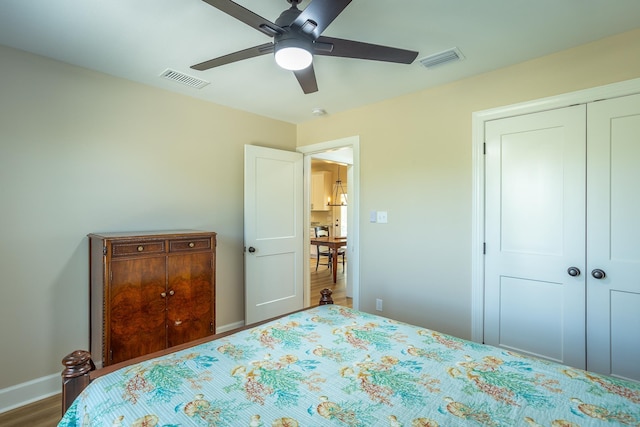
[314, 36, 418, 64]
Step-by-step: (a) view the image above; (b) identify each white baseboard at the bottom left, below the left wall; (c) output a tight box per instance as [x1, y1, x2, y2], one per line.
[0, 372, 62, 413]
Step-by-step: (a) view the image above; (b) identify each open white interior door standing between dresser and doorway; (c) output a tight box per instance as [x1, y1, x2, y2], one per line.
[244, 145, 308, 324]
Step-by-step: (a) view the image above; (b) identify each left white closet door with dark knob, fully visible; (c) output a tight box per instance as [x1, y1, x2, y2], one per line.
[484, 105, 586, 368]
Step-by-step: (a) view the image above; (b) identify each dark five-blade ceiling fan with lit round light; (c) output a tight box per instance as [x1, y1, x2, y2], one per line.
[191, 0, 418, 94]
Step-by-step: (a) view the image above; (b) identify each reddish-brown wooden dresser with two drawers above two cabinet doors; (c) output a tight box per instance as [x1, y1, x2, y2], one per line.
[88, 230, 216, 366]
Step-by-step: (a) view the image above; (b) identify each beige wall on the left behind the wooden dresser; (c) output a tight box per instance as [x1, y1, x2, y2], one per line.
[0, 46, 296, 394]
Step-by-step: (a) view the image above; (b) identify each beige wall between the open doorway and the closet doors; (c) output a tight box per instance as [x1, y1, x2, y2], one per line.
[298, 30, 640, 338]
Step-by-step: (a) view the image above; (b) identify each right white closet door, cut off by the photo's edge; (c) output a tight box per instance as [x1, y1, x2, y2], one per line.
[585, 95, 640, 381]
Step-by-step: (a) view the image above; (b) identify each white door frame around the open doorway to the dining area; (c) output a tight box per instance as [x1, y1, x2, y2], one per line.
[296, 135, 360, 310]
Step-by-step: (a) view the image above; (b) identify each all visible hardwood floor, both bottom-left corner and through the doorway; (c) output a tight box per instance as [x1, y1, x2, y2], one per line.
[0, 258, 353, 427]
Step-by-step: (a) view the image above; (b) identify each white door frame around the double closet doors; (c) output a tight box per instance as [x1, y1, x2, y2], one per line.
[471, 78, 640, 343]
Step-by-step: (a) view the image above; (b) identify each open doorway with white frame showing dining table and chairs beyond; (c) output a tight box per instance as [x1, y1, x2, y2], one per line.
[298, 137, 360, 309]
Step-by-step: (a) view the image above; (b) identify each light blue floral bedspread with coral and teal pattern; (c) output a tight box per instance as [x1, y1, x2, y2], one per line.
[59, 305, 640, 427]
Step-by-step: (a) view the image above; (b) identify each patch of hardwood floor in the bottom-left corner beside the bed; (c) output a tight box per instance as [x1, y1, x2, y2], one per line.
[0, 394, 62, 427]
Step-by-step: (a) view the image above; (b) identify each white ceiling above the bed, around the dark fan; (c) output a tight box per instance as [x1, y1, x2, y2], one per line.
[0, 0, 640, 123]
